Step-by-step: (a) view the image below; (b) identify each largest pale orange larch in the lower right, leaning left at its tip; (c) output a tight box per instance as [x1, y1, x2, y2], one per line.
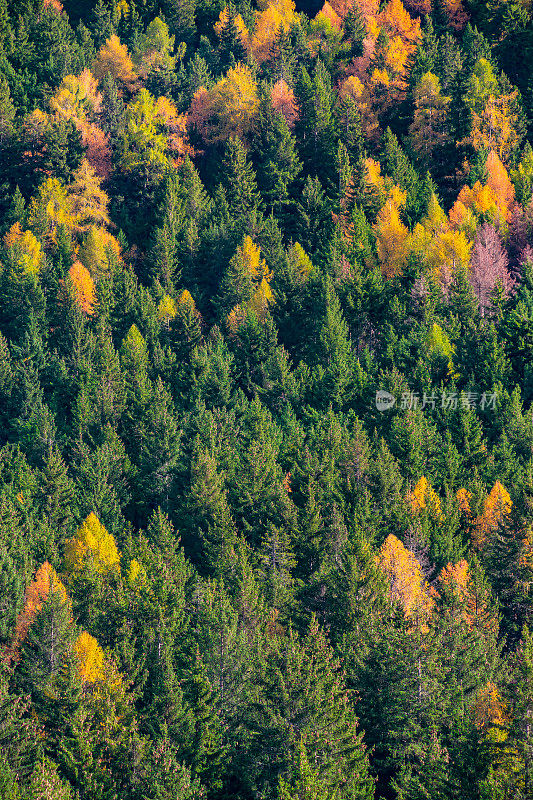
[376, 534, 435, 620]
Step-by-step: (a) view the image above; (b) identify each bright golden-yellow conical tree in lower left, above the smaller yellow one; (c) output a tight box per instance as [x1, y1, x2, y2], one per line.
[65, 512, 120, 575]
